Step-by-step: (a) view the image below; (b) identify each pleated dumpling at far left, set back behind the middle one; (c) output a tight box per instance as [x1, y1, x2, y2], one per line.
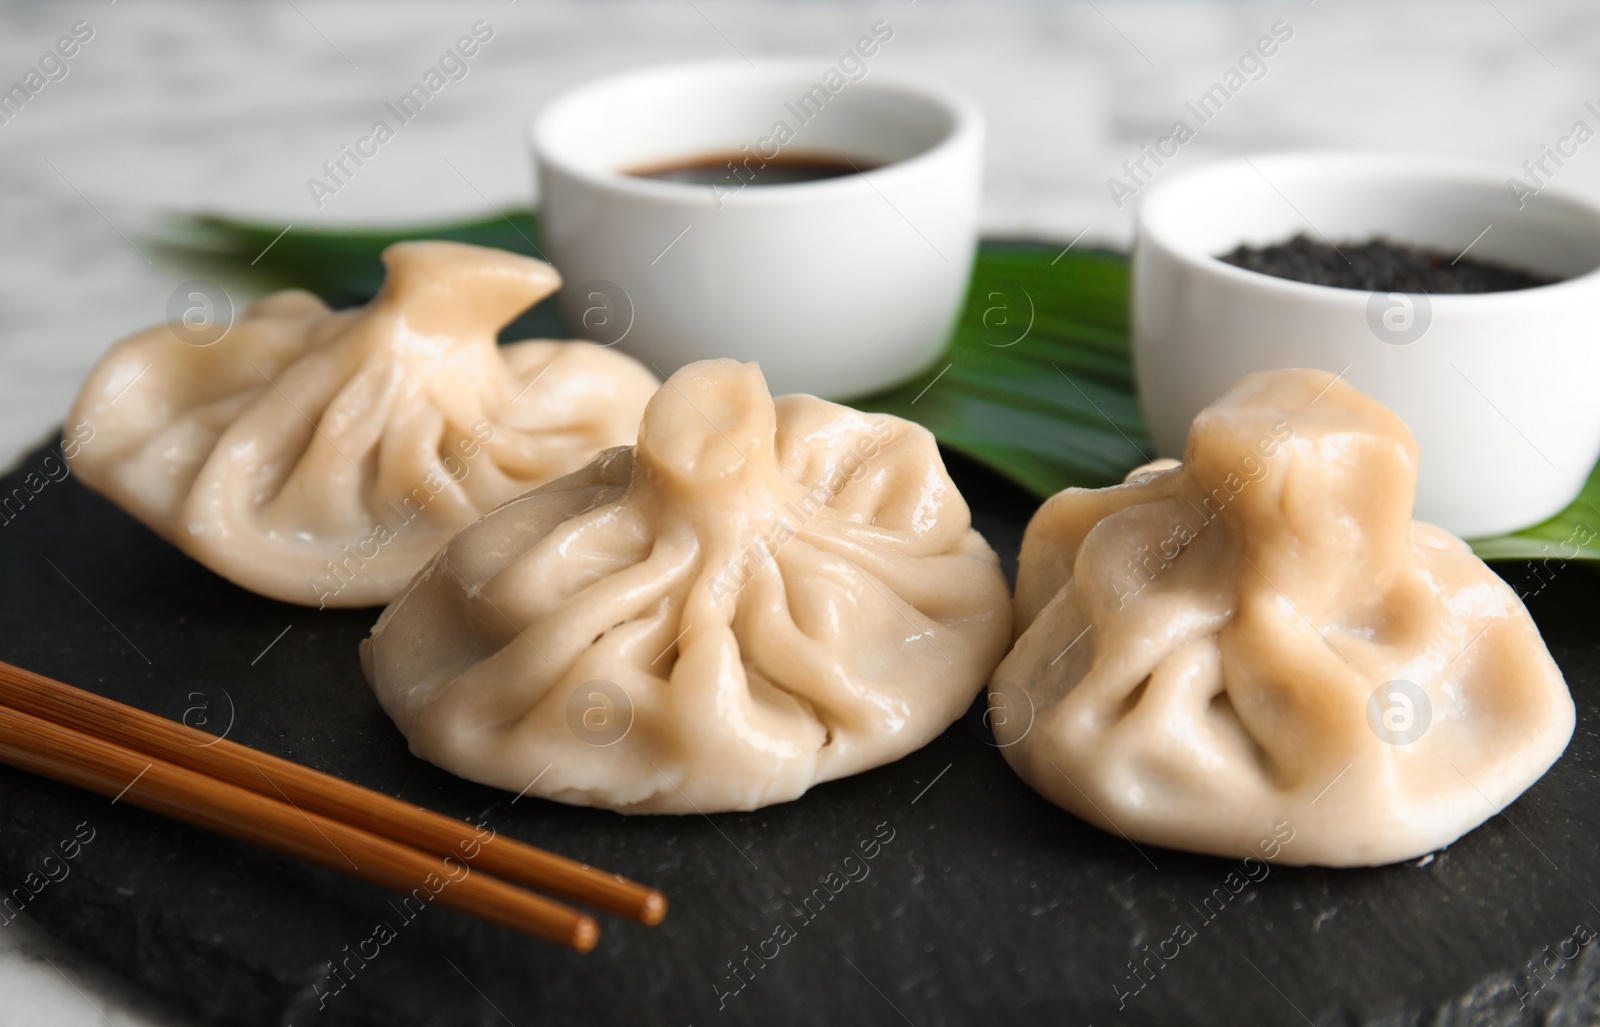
[69, 242, 659, 606]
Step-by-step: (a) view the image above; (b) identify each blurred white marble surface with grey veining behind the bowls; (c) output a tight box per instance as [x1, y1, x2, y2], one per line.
[0, 0, 1600, 1027]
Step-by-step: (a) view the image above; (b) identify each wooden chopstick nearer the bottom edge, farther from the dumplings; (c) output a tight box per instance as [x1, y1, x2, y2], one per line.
[0, 705, 600, 952]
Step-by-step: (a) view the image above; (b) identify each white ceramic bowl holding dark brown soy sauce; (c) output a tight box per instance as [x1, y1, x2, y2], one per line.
[531, 61, 982, 398]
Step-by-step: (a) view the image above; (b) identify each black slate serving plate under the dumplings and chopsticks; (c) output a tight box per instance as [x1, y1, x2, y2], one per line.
[0, 435, 1600, 1027]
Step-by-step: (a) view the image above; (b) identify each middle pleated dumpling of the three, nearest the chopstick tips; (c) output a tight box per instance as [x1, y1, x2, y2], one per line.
[362, 360, 1011, 813]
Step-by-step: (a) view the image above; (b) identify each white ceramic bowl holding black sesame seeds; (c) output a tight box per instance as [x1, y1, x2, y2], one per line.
[1133, 152, 1600, 537]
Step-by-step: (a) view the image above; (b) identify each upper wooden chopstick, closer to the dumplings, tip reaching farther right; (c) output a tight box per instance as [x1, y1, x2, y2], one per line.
[0, 661, 667, 925]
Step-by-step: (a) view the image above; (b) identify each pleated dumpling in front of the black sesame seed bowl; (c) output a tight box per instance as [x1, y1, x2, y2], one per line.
[990, 371, 1573, 865]
